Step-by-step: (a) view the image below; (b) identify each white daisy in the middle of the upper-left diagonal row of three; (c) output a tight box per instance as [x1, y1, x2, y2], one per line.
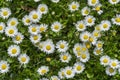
[29, 11, 42, 23]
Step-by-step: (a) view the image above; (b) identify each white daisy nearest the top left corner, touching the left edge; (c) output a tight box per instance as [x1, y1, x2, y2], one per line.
[0, 8, 11, 19]
